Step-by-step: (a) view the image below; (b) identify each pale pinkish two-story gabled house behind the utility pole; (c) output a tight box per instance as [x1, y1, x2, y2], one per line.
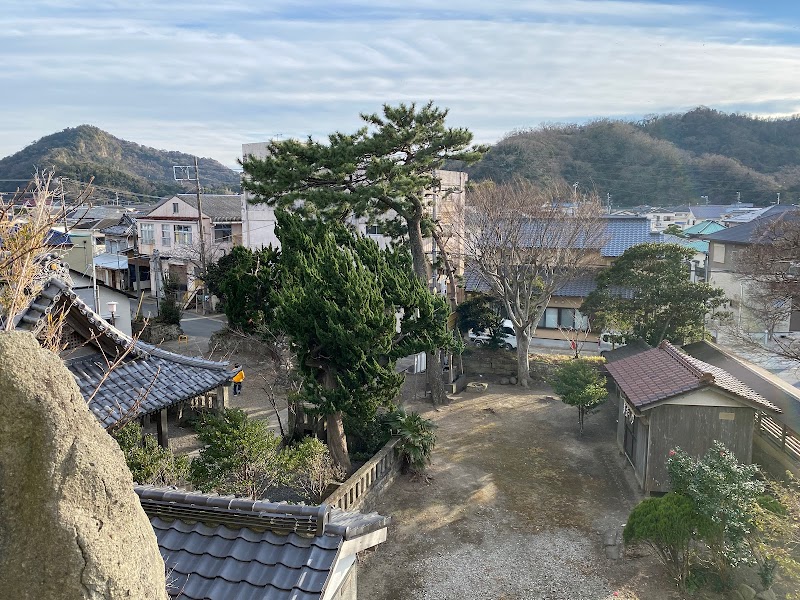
[137, 194, 242, 298]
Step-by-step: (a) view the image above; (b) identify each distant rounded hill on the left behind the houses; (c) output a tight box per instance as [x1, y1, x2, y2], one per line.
[0, 125, 240, 202]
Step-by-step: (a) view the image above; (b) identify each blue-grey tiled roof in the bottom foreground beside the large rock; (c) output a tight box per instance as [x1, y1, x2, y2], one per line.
[135, 486, 388, 600]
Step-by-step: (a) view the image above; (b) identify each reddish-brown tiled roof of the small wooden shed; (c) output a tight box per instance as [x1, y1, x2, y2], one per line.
[606, 341, 780, 412]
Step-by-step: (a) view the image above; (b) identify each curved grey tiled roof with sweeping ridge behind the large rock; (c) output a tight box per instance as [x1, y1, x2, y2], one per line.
[15, 277, 235, 426]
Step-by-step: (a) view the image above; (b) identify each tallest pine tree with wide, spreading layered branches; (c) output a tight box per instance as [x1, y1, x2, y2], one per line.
[242, 102, 485, 402]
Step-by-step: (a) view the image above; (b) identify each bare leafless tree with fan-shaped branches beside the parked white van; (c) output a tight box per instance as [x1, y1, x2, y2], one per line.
[456, 180, 606, 387]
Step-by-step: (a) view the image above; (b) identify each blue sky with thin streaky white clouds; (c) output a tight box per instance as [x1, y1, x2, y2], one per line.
[0, 0, 800, 167]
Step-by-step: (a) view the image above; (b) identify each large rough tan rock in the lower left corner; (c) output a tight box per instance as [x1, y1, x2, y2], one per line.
[0, 332, 167, 600]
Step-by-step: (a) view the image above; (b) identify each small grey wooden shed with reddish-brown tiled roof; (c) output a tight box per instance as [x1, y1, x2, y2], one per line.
[606, 341, 781, 493]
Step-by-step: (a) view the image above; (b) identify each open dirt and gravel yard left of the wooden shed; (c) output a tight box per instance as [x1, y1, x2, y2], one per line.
[358, 384, 720, 600]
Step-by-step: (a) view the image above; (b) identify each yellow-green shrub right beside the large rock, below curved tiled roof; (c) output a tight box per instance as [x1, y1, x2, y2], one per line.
[114, 422, 189, 485]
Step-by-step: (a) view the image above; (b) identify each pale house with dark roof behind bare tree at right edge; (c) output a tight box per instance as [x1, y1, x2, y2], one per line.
[702, 205, 800, 333]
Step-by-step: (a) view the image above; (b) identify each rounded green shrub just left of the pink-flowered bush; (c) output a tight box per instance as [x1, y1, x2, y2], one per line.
[623, 493, 699, 590]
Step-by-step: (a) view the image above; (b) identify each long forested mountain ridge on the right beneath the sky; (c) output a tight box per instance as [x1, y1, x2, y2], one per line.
[468, 107, 800, 207]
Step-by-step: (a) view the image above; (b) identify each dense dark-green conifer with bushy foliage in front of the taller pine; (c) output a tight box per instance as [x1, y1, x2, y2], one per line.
[275, 211, 449, 469]
